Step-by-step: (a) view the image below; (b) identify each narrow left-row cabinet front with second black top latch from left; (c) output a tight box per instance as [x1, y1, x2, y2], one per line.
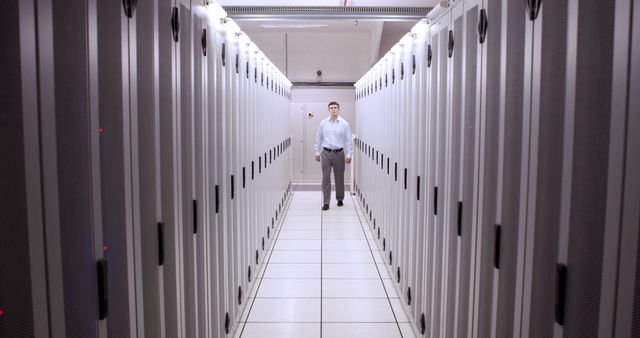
[158, 1, 191, 337]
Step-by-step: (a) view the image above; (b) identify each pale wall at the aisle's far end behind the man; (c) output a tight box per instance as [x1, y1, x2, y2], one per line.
[291, 88, 356, 183]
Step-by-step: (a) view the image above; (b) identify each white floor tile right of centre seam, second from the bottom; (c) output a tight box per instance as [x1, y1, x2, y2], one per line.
[322, 299, 396, 323]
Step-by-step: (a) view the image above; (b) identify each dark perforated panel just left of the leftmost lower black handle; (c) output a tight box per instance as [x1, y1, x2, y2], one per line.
[52, 0, 97, 338]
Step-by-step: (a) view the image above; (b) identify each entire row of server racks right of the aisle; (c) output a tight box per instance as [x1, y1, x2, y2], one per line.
[355, 0, 640, 338]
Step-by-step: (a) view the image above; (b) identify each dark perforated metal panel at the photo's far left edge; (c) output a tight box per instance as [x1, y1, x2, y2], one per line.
[0, 0, 36, 337]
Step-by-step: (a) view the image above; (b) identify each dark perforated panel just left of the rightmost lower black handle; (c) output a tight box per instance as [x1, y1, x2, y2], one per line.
[523, 0, 567, 337]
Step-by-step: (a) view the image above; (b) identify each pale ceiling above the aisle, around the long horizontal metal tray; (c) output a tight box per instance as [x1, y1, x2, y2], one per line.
[217, 0, 440, 82]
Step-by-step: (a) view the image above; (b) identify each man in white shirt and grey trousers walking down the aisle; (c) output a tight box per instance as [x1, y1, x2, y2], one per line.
[314, 102, 353, 210]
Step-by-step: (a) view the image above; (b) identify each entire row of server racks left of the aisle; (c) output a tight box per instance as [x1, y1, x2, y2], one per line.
[0, 0, 291, 338]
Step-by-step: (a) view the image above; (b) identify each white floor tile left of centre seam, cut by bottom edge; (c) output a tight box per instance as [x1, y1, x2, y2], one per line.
[241, 323, 320, 338]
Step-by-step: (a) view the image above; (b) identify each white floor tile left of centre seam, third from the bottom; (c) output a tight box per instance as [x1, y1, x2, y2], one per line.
[256, 279, 321, 298]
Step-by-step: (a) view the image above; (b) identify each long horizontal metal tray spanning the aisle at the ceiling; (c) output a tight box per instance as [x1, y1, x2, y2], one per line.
[224, 6, 432, 21]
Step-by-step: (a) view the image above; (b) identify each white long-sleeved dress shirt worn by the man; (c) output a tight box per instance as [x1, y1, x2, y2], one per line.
[314, 116, 353, 158]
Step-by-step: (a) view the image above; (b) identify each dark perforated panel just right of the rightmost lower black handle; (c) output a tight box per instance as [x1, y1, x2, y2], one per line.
[565, 1, 615, 338]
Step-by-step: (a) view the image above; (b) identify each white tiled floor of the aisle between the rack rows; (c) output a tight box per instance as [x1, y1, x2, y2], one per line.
[237, 191, 414, 338]
